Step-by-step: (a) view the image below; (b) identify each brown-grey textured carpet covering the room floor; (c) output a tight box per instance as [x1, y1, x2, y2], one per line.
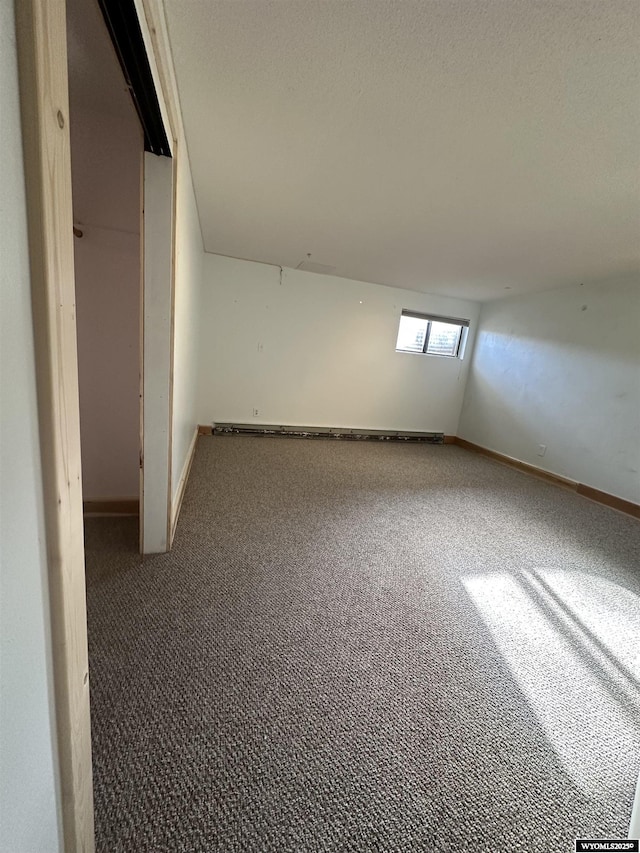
[86, 437, 640, 853]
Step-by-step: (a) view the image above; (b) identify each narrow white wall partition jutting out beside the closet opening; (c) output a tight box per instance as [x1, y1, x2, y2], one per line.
[143, 151, 204, 553]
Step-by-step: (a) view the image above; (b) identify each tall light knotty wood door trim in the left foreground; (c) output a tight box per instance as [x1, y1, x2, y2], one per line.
[15, 0, 94, 853]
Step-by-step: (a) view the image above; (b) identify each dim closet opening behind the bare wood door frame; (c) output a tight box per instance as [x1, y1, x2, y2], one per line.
[66, 0, 144, 528]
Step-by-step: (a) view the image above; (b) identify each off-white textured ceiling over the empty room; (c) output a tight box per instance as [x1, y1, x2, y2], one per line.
[165, 0, 640, 300]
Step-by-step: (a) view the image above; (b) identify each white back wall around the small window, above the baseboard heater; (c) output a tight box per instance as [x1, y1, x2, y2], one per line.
[198, 254, 479, 434]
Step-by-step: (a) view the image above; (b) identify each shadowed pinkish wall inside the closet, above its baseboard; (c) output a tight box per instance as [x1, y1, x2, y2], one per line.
[69, 110, 143, 500]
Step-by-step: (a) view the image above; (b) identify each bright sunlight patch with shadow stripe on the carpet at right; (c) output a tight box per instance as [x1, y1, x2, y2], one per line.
[463, 571, 640, 796]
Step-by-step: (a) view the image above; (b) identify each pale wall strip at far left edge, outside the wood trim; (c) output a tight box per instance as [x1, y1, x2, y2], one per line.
[0, 2, 62, 853]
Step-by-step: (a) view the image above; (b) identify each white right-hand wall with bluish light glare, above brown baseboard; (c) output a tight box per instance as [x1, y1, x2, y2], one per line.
[459, 278, 640, 503]
